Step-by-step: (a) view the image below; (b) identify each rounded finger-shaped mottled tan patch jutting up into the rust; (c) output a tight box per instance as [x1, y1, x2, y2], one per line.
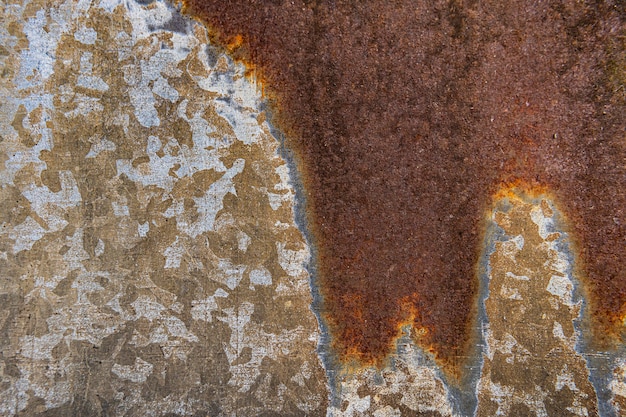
[477, 194, 598, 416]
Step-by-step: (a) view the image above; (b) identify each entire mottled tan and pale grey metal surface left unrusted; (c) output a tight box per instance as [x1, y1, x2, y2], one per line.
[0, 0, 626, 417]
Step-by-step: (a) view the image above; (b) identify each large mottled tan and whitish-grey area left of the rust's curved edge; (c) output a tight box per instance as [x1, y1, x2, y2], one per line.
[0, 1, 328, 416]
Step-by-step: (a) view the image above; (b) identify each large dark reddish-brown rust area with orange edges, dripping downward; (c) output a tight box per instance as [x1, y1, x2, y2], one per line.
[179, 0, 626, 368]
